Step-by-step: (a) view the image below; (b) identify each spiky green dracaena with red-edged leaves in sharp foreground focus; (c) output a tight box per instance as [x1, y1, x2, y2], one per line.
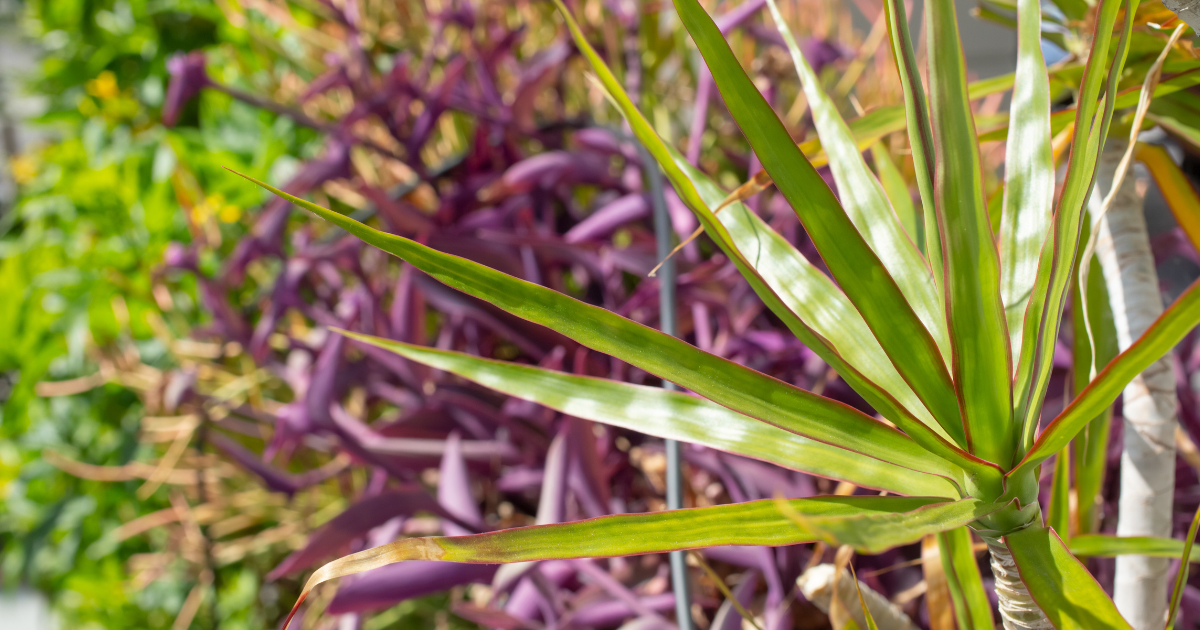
[226, 0, 1200, 629]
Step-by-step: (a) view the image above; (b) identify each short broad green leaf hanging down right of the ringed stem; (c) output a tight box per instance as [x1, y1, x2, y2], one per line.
[1004, 527, 1133, 630]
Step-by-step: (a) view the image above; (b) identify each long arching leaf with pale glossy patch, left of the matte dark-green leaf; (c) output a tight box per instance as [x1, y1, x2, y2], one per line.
[559, 0, 984, 470]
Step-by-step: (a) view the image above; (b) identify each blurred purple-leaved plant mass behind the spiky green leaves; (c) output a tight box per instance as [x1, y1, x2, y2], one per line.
[136, 0, 873, 626]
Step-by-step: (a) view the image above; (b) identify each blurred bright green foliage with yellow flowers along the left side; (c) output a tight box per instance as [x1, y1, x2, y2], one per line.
[0, 0, 336, 629]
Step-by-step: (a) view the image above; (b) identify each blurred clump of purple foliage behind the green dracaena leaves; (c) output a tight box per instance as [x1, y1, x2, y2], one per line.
[150, 0, 969, 630]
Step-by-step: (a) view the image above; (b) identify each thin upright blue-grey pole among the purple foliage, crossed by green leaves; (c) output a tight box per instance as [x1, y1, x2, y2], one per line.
[637, 143, 692, 630]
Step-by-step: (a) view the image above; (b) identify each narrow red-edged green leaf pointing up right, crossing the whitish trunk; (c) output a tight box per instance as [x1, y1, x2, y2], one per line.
[1007, 274, 1200, 479]
